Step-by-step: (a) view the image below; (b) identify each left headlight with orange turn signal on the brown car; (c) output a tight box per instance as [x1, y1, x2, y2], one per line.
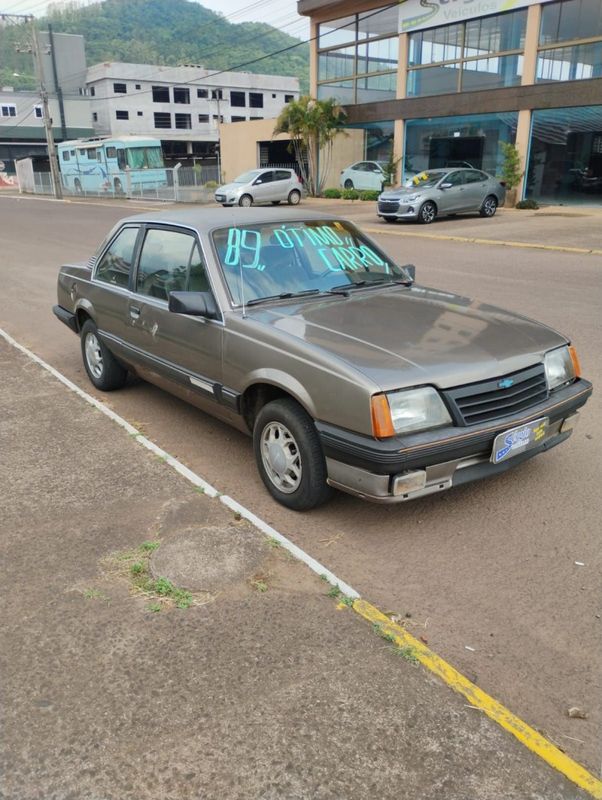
[372, 386, 451, 438]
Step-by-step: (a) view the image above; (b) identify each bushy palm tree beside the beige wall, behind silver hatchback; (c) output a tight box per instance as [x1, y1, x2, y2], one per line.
[274, 96, 346, 197]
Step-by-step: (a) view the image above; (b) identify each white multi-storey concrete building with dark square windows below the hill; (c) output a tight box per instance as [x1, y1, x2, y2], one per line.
[86, 62, 299, 160]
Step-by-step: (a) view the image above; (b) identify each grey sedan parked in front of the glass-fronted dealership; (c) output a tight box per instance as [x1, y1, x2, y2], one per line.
[376, 169, 506, 225]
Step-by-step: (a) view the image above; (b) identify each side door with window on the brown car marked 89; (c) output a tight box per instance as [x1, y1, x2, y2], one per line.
[128, 226, 223, 401]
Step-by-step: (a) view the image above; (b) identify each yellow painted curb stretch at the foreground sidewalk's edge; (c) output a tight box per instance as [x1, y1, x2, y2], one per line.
[353, 600, 602, 800]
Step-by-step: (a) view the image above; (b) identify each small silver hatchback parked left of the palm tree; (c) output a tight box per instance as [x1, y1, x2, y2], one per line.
[215, 169, 303, 206]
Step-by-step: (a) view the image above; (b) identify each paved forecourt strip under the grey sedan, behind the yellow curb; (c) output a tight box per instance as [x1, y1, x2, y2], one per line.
[304, 198, 602, 257]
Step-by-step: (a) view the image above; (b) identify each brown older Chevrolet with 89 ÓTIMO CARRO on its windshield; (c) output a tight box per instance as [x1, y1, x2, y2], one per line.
[53, 209, 592, 510]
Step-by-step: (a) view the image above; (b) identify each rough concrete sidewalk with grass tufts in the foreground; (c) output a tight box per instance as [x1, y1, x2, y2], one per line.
[0, 339, 588, 800]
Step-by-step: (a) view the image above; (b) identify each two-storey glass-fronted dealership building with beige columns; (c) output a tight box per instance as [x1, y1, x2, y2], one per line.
[308, 0, 602, 204]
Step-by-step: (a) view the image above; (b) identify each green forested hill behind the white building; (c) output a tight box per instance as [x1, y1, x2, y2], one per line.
[0, 0, 309, 91]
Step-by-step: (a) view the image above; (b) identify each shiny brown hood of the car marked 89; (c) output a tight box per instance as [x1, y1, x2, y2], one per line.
[247, 285, 567, 390]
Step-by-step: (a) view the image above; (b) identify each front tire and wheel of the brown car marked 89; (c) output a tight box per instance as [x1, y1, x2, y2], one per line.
[253, 398, 332, 511]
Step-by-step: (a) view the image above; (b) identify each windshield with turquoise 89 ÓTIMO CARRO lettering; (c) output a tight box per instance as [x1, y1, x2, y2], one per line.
[213, 220, 408, 305]
